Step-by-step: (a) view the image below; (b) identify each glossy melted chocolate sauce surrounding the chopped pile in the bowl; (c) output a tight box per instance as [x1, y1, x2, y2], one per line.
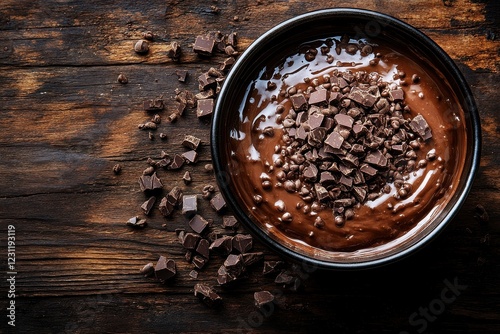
[228, 37, 467, 253]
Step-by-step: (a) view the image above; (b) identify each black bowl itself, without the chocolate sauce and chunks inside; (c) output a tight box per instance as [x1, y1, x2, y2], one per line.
[211, 8, 481, 269]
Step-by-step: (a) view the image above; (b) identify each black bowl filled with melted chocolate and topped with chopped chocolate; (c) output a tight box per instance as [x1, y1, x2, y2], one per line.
[211, 9, 480, 269]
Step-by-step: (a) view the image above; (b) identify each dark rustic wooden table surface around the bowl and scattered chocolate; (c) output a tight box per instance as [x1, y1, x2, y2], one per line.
[0, 0, 500, 333]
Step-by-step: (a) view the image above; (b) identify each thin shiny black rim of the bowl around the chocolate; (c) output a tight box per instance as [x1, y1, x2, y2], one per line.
[210, 7, 481, 270]
